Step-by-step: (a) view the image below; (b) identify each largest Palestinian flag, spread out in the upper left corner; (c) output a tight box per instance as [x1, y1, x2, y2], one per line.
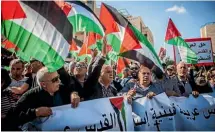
[1, 1, 73, 71]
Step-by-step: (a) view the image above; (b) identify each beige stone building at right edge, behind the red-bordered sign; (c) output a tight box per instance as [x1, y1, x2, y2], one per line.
[200, 22, 215, 54]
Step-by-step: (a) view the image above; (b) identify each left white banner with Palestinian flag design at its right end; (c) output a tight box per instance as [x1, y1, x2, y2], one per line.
[22, 97, 134, 131]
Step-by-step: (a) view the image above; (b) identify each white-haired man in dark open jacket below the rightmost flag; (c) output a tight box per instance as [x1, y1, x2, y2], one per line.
[173, 62, 199, 97]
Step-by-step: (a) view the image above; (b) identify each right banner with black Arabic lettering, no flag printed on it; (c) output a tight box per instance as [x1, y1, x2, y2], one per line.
[132, 92, 215, 131]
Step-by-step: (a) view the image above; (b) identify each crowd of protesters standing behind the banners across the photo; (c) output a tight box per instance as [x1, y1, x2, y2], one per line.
[1, 38, 215, 130]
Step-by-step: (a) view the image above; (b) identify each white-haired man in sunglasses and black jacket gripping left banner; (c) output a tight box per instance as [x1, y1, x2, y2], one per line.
[2, 67, 80, 130]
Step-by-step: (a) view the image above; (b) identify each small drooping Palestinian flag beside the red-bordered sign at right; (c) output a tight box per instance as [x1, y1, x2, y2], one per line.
[165, 19, 198, 64]
